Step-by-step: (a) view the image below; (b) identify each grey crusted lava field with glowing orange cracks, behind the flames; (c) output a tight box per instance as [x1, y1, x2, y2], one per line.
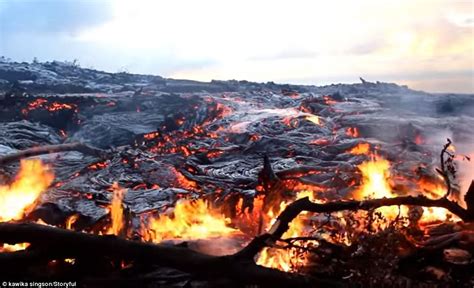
[0, 61, 474, 286]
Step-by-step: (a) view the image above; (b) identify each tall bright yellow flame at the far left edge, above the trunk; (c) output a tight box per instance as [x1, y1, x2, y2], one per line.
[0, 159, 54, 222]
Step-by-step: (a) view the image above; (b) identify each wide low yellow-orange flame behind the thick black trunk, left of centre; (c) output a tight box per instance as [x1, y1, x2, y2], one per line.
[142, 199, 238, 243]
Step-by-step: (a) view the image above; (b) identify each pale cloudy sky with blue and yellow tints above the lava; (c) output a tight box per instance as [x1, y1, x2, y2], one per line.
[0, 0, 474, 93]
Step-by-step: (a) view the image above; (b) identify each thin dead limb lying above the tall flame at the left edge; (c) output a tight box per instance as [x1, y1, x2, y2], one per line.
[0, 142, 107, 165]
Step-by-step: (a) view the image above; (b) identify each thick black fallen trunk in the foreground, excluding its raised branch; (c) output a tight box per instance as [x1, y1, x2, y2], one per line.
[0, 223, 341, 287]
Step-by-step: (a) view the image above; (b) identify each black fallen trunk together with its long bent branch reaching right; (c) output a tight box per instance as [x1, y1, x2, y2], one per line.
[0, 196, 474, 287]
